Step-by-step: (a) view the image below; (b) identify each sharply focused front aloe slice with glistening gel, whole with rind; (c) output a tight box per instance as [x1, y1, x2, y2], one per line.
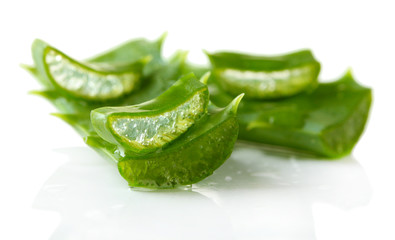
[91, 74, 209, 152]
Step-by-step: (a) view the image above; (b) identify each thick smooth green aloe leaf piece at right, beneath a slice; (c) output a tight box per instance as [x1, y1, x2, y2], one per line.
[211, 72, 372, 158]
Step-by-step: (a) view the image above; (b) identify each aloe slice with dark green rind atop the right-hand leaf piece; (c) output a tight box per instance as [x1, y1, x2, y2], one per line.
[207, 50, 320, 99]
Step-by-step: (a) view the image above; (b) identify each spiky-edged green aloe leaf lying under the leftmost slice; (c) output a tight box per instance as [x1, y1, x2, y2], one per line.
[22, 37, 176, 161]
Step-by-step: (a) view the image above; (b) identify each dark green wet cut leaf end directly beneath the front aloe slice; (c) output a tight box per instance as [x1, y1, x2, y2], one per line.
[118, 95, 243, 188]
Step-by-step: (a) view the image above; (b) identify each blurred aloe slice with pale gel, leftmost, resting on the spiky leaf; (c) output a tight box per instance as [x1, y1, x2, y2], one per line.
[32, 39, 151, 101]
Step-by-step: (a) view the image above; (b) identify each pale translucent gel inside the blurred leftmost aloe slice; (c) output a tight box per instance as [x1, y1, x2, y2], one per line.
[45, 50, 138, 99]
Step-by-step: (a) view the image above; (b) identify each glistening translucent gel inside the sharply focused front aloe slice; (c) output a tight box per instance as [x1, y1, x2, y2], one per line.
[111, 92, 205, 148]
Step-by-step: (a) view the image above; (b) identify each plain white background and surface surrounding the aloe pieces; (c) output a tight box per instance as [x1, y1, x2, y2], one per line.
[0, 0, 395, 240]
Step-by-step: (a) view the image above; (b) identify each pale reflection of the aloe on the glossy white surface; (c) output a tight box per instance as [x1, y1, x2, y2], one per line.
[34, 144, 371, 239]
